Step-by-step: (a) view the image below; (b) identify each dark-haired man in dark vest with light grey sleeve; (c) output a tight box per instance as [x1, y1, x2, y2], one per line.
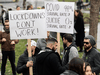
[62, 34, 79, 66]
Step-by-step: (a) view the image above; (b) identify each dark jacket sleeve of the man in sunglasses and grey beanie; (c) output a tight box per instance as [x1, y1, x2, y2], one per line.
[92, 53, 100, 73]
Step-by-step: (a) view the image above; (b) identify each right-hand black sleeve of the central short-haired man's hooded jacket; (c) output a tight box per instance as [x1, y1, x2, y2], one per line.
[49, 54, 66, 75]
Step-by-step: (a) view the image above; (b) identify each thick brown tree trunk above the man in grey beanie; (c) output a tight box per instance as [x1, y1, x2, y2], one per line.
[89, 0, 100, 44]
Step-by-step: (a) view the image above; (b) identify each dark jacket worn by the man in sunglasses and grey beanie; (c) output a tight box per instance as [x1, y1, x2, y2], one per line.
[83, 48, 100, 75]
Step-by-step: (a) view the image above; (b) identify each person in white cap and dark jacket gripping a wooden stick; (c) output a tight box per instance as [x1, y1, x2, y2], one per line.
[17, 40, 39, 75]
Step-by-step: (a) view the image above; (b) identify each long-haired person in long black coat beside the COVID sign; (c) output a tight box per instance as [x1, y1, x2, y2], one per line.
[74, 10, 85, 52]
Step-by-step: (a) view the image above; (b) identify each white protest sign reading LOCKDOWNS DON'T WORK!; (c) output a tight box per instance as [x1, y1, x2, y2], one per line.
[9, 10, 47, 39]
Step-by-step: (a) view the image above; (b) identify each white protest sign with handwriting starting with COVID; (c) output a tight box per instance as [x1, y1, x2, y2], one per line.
[45, 2, 74, 33]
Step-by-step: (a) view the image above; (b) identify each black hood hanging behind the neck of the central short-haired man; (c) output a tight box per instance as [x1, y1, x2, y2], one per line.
[36, 50, 53, 64]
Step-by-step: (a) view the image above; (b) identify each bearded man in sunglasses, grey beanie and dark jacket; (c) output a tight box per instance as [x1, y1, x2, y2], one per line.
[83, 35, 100, 75]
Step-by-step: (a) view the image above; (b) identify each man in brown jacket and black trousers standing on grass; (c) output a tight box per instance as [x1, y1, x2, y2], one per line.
[0, 20, 19, 75]
